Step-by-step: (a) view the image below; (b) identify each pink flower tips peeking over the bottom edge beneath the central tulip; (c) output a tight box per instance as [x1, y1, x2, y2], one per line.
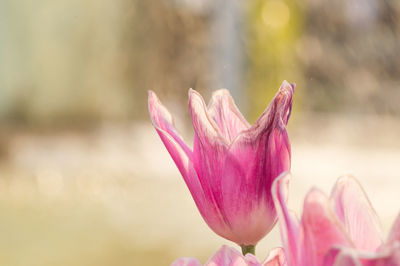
[171, 246, 287, 266]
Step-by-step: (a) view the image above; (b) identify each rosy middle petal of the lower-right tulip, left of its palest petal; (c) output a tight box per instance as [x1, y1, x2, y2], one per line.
[301, 189, 352, 265]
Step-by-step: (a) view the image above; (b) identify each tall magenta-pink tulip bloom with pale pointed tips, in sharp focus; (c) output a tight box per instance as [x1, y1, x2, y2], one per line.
[149, 81, 295, 246]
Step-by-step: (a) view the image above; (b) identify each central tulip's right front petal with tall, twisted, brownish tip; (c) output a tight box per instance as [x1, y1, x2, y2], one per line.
[221, 82, 294, 244]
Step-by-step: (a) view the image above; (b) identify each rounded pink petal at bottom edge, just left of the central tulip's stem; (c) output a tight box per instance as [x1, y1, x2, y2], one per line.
[205, 246, 247, 266]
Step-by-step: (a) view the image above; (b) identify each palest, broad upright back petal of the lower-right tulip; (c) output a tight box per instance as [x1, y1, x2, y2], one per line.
[331, 176, 383, 251]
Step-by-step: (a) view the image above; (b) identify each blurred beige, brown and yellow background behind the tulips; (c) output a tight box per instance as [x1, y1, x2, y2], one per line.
[0, 0, 400, 266]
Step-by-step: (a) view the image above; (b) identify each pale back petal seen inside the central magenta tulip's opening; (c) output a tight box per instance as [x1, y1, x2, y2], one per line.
[208, 89, 250, 142]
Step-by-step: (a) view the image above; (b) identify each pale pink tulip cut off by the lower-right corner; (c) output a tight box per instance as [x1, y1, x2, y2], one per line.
[272, 174, 400, 266]
